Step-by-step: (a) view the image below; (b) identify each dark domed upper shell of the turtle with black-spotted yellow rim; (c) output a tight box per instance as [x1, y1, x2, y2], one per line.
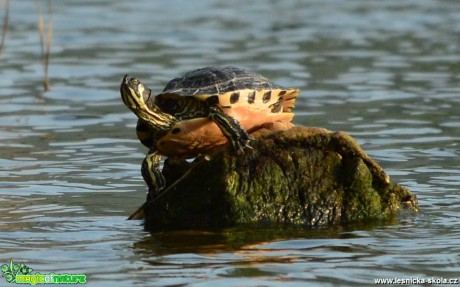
[155, 66, 299, 120]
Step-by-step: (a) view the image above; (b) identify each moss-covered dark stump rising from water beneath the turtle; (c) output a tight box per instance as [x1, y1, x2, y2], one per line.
[137, 127, 417, 229]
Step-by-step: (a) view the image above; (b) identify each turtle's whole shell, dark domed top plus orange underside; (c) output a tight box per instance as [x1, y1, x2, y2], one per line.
[137, 66, 299, 156]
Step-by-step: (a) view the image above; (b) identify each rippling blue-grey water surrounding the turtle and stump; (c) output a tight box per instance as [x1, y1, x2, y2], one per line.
[0, 0, 460, 286]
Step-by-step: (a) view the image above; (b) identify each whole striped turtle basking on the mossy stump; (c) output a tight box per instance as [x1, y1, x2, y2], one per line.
[120, 66, 300, 205]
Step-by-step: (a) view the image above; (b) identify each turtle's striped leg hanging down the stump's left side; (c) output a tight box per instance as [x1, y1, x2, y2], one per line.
[141, 150, 166, 201]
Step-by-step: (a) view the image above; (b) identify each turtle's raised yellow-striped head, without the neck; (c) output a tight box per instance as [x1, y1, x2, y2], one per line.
[120, 75, 152, 111]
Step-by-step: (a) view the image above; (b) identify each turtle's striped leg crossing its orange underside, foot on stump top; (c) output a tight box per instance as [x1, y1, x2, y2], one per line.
[208, 106, 253, 151]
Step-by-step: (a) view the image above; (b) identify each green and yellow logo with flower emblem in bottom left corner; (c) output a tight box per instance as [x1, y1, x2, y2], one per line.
[2, 260, 86, 285]
